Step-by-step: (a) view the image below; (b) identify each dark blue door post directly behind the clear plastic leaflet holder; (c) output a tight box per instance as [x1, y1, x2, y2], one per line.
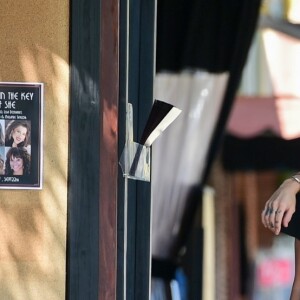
[126, 0, 156, 300]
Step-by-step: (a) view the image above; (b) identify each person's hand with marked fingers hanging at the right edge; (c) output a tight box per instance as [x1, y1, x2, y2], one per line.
[261, 178, 300, 235]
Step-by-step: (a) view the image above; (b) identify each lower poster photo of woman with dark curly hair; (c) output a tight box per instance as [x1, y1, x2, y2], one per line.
[5, 147, 31, 176]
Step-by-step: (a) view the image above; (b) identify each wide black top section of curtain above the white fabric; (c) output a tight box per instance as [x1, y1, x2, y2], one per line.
[156, 0, 260, 73]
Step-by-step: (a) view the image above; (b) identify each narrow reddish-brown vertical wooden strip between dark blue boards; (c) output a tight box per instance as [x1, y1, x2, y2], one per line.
[98, 0, 119, 300]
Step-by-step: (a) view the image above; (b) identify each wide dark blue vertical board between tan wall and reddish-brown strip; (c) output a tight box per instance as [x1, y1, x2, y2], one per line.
[66, 0, 100, 300]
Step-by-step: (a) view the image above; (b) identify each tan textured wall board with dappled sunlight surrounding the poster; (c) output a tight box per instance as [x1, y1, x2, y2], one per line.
[0, 0, 69, 300]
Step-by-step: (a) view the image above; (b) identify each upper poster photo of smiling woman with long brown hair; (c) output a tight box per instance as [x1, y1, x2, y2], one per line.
[5, 120, 31, 147]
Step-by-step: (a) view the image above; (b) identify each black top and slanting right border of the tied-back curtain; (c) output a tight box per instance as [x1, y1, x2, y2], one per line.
[152, 0, 261, 298]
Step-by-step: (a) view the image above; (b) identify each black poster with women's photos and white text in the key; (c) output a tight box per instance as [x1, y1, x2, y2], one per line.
[0, 82, 44, 189]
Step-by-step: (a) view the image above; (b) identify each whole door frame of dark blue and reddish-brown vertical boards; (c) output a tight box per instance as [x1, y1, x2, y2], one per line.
[66, 0, 156, 300]
